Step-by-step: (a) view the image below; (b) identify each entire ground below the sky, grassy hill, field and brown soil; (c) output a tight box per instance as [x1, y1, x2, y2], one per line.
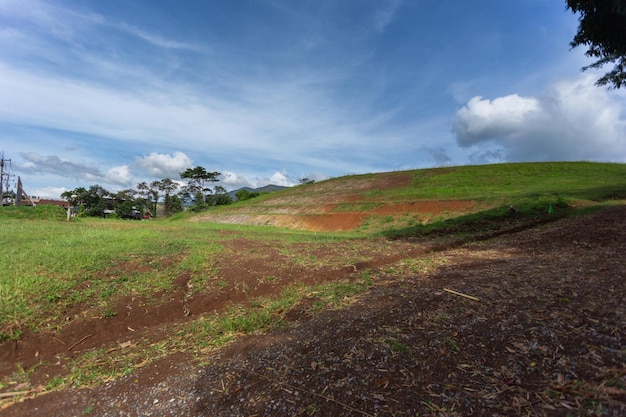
[0, 163, 626, 417]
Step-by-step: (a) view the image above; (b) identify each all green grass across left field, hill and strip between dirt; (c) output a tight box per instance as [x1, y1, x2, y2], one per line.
[0, 162, 626, 385]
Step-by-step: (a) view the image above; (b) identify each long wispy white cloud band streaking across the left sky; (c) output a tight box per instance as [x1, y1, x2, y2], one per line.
[0, 64, 332, 159]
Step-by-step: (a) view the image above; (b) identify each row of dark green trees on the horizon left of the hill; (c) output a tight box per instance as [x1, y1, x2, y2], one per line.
[61, 166, 249, 218]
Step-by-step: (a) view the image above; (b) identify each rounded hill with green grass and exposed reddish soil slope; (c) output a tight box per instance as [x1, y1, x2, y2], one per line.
[191, 162, 626, 233]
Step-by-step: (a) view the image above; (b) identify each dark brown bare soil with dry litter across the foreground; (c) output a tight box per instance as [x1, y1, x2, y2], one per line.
[0, 206, 626, 416]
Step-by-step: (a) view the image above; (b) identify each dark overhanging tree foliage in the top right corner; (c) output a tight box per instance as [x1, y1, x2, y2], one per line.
[567, 0, 626, 88]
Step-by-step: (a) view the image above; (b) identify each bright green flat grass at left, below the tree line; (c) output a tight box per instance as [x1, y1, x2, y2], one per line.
[0, 219, 220, 339]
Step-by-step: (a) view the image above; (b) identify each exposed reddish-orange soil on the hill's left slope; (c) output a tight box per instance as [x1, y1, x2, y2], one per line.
[191, 172, 477, 232]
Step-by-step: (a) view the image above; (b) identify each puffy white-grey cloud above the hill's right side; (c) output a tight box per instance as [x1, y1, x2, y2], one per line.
[452, 76, 626, 162]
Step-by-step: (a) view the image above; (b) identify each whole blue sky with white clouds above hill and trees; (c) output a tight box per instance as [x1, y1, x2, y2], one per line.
[0, 0, 626, 197]
